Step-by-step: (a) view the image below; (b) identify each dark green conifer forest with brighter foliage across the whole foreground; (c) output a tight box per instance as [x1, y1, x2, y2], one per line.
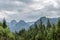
[0, 19, 60, 40]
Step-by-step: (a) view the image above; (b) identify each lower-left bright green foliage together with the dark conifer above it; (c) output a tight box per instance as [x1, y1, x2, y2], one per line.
[0, 20, 15, 40]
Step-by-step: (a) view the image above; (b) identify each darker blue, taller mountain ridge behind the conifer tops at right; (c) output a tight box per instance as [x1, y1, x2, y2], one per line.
[31, 17, 59, 27]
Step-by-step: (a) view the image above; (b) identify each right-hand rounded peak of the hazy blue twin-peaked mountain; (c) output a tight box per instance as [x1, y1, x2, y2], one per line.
[15, 20, 29, 31]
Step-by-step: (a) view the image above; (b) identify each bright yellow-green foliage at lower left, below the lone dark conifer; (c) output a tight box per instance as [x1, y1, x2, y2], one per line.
[0, 26, 15, 40]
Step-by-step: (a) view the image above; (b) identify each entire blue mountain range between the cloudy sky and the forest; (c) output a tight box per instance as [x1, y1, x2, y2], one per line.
[9, 17, 59, 32]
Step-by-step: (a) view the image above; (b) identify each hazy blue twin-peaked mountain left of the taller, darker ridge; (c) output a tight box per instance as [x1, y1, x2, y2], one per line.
[9, 20, 33, 32]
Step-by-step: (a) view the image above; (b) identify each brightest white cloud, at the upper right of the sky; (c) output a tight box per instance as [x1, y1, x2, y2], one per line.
[29, 0, 58, 10]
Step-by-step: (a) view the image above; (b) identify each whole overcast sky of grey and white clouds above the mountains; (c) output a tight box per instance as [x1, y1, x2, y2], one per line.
[0, 0, 60, 22]
